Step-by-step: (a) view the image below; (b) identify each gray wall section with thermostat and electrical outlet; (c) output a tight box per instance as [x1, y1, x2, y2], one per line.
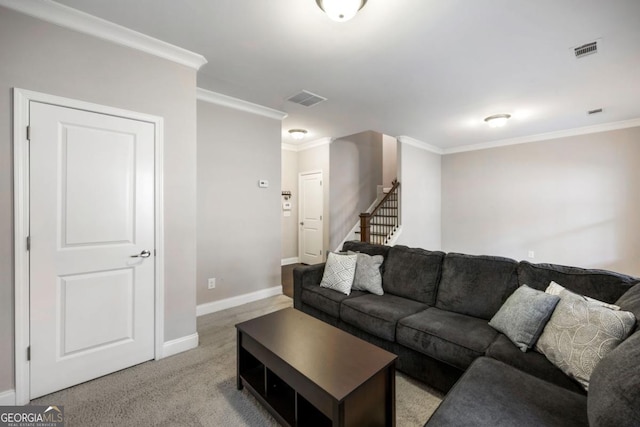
[197, 101, 282, 304]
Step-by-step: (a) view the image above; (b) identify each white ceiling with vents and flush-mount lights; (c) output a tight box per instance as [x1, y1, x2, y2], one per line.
[52, 0, 640, 149]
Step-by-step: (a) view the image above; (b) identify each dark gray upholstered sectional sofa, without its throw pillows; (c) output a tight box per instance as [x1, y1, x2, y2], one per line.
[294, 242, 640, 426]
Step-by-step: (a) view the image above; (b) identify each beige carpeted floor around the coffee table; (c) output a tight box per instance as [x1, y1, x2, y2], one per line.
[31, 296, 442, 427]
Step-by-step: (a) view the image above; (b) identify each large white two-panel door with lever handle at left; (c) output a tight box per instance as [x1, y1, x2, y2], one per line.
[29, 102, 155, 398]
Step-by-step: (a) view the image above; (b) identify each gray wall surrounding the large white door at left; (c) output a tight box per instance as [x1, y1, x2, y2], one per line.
[0, 7, 196, 392]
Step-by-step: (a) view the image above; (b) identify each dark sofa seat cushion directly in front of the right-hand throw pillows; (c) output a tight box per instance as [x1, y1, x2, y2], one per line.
[485, 334, 585, 394]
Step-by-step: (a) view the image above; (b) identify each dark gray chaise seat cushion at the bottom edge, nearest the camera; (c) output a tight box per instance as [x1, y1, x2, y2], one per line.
[426, 357, 588, 427]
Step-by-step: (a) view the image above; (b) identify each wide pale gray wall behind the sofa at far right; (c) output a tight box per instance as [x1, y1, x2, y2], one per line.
[442, 127, 640, 275]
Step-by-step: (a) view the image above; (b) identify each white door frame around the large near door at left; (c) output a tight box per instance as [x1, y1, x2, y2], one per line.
[13, 88, 164, 405]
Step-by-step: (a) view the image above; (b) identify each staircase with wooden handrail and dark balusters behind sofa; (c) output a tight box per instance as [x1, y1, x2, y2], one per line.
[356, 180, 400, 245]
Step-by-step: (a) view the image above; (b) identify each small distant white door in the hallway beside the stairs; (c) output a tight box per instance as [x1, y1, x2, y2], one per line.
[298, 172, 324, 265]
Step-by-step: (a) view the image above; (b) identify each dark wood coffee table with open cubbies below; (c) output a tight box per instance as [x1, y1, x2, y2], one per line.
[236, 308, 397, 427]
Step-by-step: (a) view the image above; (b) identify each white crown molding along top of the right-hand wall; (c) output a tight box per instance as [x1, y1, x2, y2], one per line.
[442, 118, 640, 155]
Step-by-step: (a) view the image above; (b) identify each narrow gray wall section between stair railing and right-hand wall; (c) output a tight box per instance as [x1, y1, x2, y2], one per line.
[397, 141, 442, 250]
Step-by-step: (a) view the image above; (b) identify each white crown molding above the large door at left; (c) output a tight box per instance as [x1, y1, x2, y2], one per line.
[0, 0, 207, 70]
